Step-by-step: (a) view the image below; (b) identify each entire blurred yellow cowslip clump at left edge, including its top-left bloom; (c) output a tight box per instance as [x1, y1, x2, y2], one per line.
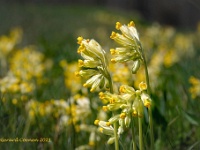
[0, 28, 52, 110]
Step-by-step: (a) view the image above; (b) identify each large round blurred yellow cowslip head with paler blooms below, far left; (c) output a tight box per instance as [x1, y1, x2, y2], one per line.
[0, 47, 48, 94]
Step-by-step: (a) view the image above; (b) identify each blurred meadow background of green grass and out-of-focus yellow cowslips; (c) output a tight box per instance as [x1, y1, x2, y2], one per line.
[0, 0, 200, 150]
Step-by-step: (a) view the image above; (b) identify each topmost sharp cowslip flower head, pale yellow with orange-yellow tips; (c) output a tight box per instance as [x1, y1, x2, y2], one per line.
[110, 21, 143, 73]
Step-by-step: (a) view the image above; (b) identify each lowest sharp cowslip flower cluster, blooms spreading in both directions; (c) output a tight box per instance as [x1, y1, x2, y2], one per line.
[94, 82, 151, 144]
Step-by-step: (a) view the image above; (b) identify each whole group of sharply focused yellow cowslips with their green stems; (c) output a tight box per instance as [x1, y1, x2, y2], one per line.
[76, 21, 153, 150]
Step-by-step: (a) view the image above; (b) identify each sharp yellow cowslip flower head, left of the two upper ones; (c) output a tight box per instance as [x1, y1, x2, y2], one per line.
[75, 37, 109, 92]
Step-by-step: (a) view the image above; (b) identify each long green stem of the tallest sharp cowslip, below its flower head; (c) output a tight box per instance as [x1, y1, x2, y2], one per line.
[141, 48, 154, 150]
